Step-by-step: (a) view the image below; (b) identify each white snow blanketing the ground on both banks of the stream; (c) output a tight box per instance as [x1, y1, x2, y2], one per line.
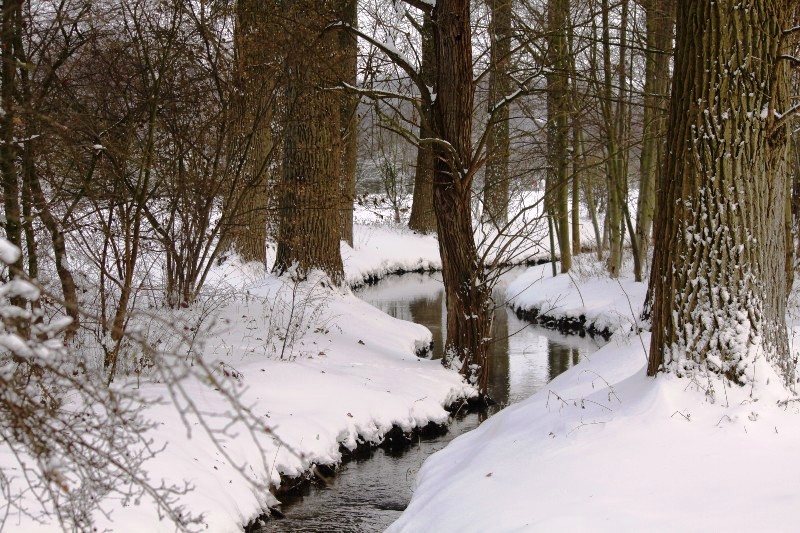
[10, 202, 788, 532]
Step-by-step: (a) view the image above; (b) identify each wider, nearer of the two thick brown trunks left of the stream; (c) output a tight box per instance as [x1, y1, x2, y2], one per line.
[274, 0, 344, 284]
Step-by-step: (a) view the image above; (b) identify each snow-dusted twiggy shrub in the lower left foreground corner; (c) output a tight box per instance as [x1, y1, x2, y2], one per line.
[0, 239, 198, 531]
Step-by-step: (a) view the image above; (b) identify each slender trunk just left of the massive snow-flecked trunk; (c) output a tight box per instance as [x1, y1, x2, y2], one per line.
[634, 0, 674, 281]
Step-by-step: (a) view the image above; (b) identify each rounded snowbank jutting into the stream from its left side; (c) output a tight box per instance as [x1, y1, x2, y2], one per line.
[109, 277, 474, 531]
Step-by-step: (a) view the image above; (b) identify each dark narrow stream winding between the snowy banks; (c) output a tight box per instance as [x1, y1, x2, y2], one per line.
[261, 274, 602, 532]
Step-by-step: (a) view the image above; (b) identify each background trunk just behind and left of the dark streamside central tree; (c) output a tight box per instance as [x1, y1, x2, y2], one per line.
[408, 15, 436, 233]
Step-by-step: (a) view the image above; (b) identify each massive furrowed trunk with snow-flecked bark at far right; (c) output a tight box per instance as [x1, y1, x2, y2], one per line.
[648, 0, 795, 383]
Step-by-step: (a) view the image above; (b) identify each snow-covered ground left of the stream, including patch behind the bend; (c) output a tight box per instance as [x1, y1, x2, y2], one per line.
[0, 224, 475, 532]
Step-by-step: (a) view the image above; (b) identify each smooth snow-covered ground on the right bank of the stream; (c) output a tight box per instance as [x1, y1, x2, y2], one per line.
[389, 256, 800, 532]
